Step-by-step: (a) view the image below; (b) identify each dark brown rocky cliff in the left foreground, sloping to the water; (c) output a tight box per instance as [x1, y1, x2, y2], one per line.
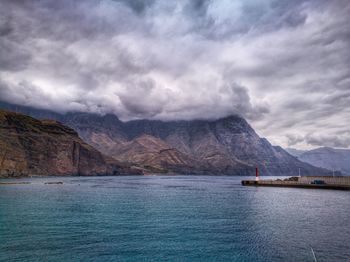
[0, 110, 140, 177]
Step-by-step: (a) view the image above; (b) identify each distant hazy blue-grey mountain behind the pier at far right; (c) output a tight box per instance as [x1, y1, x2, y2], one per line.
[299, 147, 350, 175]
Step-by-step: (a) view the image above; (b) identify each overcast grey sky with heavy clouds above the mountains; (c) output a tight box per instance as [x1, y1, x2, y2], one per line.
[0, 0, 350, 149]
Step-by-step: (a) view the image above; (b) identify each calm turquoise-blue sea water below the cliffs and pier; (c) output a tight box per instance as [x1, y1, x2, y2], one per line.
[0, 176, 350, 262]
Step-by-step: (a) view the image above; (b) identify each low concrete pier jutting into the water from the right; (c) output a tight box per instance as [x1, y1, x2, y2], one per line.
[242, 176, 350, 190]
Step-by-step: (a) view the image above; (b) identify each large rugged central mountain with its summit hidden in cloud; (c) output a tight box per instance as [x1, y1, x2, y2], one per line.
[0, 103, 328, 175]
